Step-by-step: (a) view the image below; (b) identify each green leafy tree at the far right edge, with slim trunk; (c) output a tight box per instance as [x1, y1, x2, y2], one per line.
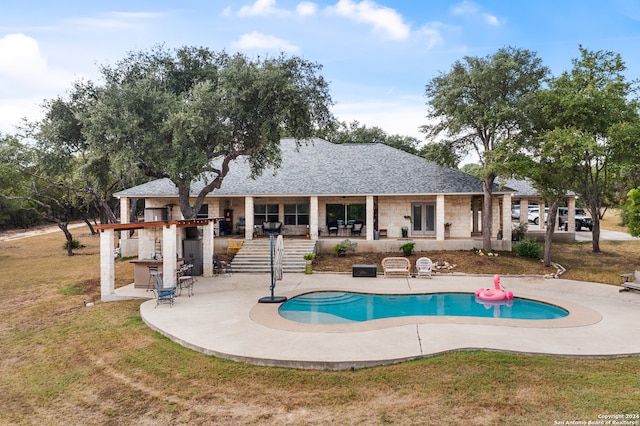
[538, 47, 640, 252]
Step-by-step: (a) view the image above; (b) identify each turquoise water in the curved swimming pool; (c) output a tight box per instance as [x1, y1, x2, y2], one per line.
[279, 291, 569, 324]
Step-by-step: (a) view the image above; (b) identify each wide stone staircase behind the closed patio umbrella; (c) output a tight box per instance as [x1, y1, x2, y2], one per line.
[231, 238, 316, 273]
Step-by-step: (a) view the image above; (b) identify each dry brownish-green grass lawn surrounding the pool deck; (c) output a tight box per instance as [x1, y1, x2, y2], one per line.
[0, 225, 640, 425]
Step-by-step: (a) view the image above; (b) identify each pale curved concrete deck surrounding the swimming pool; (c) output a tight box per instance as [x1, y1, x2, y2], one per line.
[126, 273, 640, 370]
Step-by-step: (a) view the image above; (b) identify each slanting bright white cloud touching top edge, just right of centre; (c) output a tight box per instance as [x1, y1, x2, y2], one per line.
[329, 0, 410, 40]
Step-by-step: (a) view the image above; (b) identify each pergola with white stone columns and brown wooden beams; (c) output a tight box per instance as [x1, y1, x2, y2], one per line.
[95, 218, 220, 302]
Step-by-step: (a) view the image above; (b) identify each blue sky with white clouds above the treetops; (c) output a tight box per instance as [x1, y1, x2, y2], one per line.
[0, 0, 640, 138]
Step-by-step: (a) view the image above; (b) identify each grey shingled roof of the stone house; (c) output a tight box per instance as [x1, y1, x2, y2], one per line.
[115, 138, 513, 197]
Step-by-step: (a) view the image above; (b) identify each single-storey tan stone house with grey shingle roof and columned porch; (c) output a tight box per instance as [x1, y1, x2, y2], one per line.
[95, 138, 514, 302]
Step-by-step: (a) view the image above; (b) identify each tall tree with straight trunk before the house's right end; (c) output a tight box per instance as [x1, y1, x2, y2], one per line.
[422, 47, 548, 250]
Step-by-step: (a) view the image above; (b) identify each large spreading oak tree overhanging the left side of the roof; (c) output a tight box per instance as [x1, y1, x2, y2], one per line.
[88, 46, 334, 218]
